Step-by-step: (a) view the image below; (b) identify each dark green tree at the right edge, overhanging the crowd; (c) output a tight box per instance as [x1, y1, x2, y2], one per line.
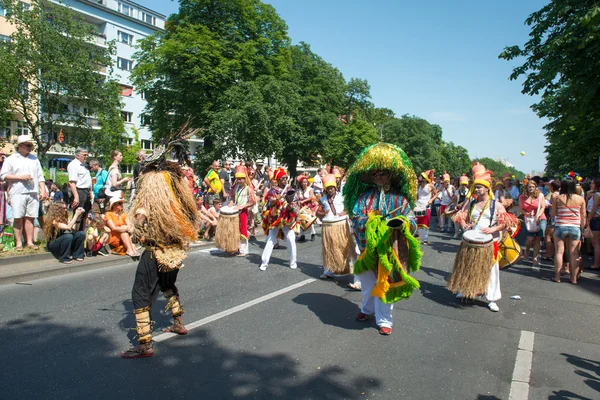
[499, 0, 600, 175]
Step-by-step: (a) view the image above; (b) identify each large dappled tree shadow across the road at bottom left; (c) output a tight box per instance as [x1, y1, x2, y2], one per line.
[0, 314, 381, 400]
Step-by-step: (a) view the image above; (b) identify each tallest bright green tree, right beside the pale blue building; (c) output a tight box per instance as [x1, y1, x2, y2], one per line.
[132, 0, 290, 145]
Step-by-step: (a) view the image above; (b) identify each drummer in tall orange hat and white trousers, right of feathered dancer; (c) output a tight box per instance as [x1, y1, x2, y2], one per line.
[454, 163, 516, 312]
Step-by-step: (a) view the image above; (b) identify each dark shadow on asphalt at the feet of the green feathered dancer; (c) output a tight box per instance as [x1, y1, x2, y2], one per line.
[293, 293, 375, 330]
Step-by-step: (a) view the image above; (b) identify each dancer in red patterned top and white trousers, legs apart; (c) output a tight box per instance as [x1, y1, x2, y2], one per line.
[259, 168, 298, 271]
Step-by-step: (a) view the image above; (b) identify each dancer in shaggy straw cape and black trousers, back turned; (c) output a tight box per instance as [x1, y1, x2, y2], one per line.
[121, 124, 200, 358]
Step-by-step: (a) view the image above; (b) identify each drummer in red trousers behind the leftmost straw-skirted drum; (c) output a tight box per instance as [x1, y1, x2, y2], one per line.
[229, 165, 256, 257]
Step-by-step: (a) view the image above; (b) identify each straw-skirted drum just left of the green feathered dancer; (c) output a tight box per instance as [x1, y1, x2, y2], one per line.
[322, 216, 356, 274]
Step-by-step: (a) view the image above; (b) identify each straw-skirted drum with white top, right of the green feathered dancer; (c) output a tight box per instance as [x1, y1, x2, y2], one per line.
[448, 230, 494, 299]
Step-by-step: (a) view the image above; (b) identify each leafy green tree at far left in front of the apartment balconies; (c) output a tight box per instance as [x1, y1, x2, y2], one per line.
[0, 0, 124, 159]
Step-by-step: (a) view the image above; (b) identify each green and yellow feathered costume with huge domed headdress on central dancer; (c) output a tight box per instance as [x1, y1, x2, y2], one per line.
[344, 143, 422, 310]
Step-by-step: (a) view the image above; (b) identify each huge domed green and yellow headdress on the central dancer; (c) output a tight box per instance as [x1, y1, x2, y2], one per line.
[344, 142, 417, 215]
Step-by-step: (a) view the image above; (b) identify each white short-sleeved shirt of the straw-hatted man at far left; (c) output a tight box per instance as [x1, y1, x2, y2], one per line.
[0, 152, 46, 195]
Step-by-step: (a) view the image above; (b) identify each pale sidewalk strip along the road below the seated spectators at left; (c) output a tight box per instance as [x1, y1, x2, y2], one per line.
[0, 235, 238, 285]
